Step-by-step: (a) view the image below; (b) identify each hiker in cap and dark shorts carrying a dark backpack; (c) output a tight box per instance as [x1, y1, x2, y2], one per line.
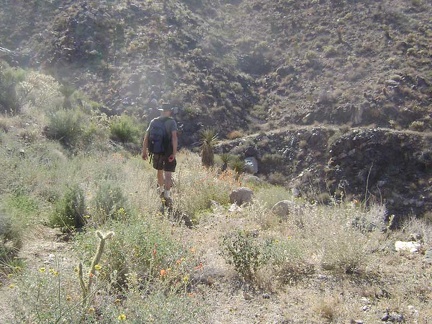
[142, 104, 177, 208]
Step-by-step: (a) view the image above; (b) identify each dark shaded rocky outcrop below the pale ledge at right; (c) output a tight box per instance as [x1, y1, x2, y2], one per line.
[218, 127, 432, 225]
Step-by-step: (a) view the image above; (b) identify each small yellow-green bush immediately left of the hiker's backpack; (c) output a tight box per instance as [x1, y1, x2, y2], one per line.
[110, 114, 140, 143]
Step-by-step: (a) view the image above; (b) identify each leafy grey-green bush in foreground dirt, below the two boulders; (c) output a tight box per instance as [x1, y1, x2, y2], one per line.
[220, 230, 272, 281]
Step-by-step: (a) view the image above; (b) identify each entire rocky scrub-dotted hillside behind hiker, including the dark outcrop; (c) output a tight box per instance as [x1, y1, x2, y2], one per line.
[0, 0, 432, 220]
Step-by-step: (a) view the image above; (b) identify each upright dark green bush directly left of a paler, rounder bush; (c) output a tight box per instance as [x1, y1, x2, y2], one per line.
[49, 185, 86, 231]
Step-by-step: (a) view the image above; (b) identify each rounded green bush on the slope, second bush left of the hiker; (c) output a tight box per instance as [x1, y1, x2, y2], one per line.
[45, 109, 84, 148]
